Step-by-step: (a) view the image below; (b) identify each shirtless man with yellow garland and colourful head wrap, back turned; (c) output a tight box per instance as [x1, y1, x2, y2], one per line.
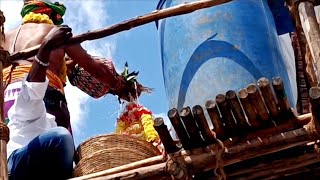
[3, 0, 140, 134]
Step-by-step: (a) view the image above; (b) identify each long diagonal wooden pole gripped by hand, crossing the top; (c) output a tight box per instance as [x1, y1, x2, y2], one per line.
[10, 0, 232, 61]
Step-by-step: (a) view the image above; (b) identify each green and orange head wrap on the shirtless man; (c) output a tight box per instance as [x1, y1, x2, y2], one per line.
[20, 0, 66, 25]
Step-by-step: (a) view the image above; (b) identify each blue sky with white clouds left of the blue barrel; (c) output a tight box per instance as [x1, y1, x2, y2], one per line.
[0, 0, 168, 146]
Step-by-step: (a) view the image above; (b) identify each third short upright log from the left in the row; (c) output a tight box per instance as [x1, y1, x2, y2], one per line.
[179, 107, 204, 149]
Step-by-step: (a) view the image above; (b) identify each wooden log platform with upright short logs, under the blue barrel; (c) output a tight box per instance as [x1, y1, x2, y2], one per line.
[74, 77, 320, 180]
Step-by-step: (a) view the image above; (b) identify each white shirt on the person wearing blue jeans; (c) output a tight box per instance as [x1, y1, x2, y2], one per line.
[7, 78, 57, 157]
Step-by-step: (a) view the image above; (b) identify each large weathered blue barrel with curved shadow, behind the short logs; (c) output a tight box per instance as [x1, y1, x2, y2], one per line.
[158, 0, 295, 108]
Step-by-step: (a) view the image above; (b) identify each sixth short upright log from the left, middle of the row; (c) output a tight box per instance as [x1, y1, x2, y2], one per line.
[216, 94, 237, 137]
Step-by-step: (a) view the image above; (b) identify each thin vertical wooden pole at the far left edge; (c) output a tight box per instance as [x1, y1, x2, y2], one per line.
[0, 11, 9, 180]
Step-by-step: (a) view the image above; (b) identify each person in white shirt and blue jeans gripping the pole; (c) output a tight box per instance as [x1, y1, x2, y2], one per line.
[7, 27, 74, 180]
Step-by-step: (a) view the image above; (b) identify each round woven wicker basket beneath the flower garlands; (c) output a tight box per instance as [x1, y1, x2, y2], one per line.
[73, 134, 160, 177]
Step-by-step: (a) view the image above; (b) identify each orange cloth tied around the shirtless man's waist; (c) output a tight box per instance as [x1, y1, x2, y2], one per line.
[2, 64, 66, 94]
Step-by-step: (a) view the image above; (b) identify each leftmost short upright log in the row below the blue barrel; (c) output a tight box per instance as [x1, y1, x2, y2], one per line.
[154, 117, 180, 154]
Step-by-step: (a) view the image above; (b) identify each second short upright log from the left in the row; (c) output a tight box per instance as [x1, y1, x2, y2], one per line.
[168, 108, 192, 150]
